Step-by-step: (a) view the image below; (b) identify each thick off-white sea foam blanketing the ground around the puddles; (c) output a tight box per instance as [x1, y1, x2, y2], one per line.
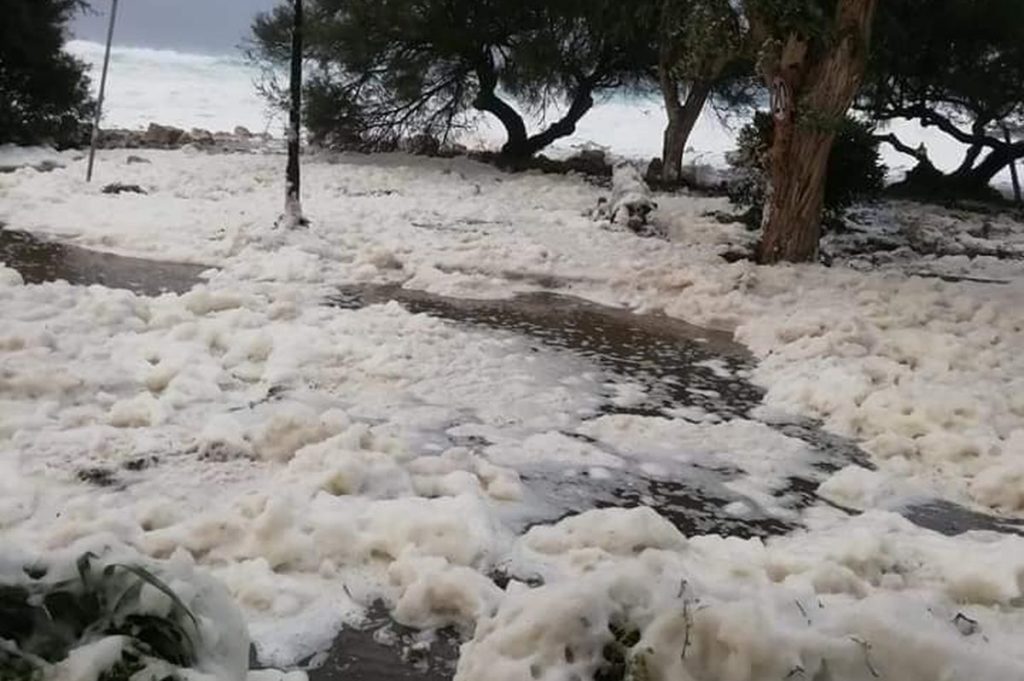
[6, 146, 1024, 681]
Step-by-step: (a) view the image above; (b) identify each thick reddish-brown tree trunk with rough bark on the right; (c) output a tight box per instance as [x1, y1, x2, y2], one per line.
[758, 0, 877, 263]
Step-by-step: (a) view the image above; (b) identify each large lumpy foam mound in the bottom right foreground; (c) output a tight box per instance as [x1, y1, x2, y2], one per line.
[456, 509, 1024, 681]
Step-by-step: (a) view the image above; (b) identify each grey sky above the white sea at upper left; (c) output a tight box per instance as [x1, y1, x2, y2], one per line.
[72, 0, 280, 54]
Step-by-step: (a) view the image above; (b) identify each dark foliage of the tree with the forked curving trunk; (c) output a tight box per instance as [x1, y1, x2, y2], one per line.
[243, 0, 651, 150]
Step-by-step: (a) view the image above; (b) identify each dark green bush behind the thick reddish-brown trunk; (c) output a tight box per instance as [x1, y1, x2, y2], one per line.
[729, 113, 886, 226]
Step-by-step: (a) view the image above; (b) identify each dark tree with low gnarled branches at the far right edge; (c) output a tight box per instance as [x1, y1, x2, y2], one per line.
[859, 0, 1024, 193]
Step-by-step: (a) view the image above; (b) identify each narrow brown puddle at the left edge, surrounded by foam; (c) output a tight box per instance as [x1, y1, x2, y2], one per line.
[0, 224, 209, 296]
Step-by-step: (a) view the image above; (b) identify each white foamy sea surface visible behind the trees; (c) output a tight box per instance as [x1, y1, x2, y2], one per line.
[68, 40, 1009, 182]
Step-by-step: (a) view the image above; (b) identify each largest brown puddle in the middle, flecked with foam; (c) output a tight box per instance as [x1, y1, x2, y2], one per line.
[329, 286, 763, 419]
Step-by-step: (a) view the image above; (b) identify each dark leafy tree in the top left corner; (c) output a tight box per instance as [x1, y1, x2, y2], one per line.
[0, 0, 94, 147]
